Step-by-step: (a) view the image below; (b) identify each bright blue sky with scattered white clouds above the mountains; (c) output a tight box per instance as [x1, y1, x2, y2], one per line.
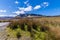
[0, 0, 60, 17]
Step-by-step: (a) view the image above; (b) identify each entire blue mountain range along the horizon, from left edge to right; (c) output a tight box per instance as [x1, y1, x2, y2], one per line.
[0, 13, 60, 20]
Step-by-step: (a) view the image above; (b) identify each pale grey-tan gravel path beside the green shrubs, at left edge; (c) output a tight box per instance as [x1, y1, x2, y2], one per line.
[0, 22, 9, 40]
